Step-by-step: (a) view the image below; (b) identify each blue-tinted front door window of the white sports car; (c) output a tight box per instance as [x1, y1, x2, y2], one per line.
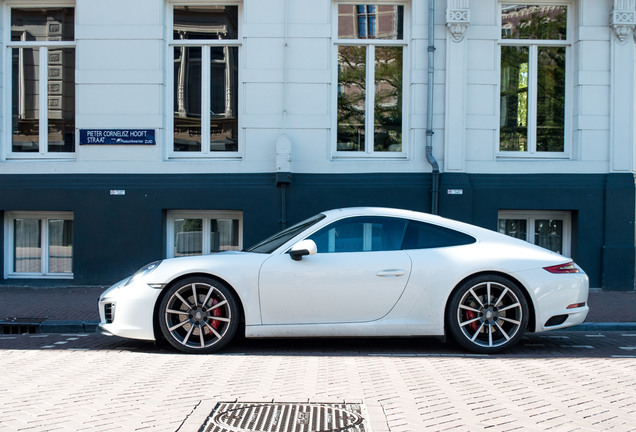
[309, 217, 406, 253]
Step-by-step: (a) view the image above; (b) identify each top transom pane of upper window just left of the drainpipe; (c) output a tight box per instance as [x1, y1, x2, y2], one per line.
[338, 5, 404, 40]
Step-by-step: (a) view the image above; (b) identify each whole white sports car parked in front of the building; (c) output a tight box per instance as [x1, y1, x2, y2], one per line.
[99, 208, 588, 353]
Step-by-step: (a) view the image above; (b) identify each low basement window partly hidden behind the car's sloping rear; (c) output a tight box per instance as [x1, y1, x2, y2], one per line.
[499, 211, 572, 256]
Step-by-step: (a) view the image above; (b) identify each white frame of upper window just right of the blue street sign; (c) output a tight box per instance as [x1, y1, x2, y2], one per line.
[165, 0, 245, 160]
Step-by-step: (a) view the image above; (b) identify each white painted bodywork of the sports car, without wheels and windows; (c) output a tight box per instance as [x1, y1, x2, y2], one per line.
[99, 208, 588, 348]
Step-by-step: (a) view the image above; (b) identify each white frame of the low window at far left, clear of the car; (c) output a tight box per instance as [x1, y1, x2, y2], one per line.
[4, 211, 75, 279]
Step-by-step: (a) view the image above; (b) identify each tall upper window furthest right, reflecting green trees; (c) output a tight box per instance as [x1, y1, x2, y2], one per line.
[499, 3, 570, 157]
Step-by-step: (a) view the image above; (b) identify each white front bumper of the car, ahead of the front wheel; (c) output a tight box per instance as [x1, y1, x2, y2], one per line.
[98, 279, 161, 340]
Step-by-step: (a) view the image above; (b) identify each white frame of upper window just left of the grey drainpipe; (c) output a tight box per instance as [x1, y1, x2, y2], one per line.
[330, 0, 411, 159]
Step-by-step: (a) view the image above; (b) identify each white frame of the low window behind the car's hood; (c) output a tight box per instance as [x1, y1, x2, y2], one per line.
[166, 210, 243, 258]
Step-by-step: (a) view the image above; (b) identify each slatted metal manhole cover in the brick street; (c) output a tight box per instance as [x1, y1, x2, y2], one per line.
[200, 402, 369, 432]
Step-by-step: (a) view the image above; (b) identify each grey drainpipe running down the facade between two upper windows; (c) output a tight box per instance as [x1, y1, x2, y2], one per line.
[426, 0, 440, 214]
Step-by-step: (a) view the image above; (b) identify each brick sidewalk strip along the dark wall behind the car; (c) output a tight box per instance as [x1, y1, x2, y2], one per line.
[0, 287, 636, 322]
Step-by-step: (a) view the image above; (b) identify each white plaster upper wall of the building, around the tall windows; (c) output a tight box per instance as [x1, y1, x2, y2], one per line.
[0, 0, 634, 173]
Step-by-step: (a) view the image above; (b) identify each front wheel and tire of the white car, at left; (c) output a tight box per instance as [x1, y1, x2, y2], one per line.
[158, 277, 240, 354]
